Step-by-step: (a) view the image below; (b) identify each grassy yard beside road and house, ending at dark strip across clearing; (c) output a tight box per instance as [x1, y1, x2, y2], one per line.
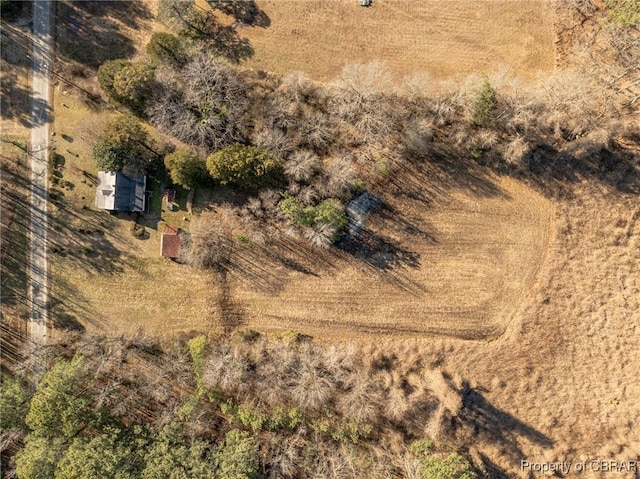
[49, 87, 222, 335]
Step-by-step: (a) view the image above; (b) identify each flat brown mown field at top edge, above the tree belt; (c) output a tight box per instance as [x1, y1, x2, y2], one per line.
[239, 0, 555, 81]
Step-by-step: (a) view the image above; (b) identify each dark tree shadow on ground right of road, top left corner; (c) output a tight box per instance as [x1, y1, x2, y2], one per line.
[56, 1, 152, 68]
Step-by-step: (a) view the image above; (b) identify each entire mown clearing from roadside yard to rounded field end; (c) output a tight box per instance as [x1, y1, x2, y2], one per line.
[51, 89, 553, 339]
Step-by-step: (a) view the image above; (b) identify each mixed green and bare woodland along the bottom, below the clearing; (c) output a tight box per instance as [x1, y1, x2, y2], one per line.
[0, 331, 474, 479]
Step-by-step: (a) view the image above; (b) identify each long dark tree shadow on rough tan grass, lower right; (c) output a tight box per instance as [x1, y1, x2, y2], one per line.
[456, 383, 554, 464]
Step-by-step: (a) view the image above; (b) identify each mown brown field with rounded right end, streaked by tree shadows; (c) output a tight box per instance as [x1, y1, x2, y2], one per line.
[232, 170, 553, 339]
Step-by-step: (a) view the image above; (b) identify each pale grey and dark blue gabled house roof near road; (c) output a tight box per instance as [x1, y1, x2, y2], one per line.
[96, 171, 147, 211]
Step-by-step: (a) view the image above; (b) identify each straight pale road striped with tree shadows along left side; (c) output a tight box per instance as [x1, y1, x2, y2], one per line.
[29, 0, 52, 343]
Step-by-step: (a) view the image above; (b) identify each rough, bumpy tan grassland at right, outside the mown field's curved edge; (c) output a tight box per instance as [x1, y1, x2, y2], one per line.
[400, 185, 640, 479]
